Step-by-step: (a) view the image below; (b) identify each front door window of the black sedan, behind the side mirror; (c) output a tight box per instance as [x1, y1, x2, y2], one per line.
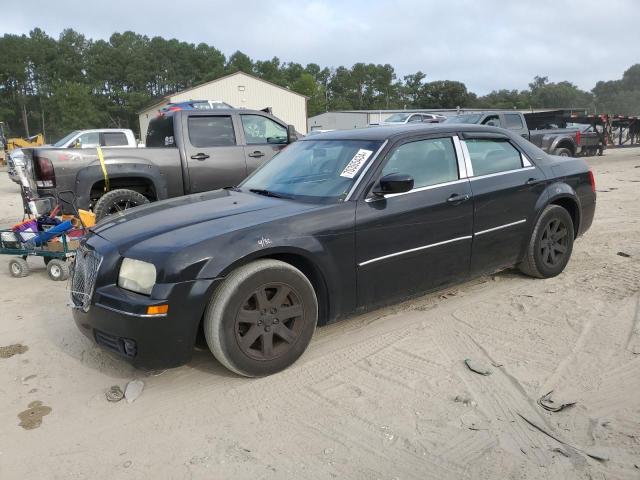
[382, 137, 458, 188]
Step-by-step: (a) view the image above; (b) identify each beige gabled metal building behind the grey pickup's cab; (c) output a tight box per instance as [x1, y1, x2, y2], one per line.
[139, 72, 307, 141]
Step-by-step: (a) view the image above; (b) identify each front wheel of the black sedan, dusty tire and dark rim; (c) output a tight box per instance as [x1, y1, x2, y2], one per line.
[204, 259, 318, 377]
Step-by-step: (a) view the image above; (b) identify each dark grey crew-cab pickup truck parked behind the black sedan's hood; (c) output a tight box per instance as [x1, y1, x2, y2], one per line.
[24, 109, 298, 219]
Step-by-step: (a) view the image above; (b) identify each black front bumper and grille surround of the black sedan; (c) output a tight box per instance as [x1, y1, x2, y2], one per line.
[72, 235, 221, 369]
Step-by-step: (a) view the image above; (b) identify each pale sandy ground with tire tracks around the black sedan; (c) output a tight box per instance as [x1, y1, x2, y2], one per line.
[0, 149, 640, 480]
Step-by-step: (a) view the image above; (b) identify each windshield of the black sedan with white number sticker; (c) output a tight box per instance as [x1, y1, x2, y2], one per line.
[239, 140, 382, 203]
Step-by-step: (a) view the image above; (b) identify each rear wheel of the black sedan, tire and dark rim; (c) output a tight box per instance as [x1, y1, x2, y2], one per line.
[518, 205, 574, 278]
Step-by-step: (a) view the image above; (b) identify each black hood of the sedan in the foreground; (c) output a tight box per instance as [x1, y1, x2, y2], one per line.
[90, 190, 317, 252]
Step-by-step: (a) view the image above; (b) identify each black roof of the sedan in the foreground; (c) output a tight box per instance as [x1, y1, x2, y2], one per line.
[301, 123, 507, 141]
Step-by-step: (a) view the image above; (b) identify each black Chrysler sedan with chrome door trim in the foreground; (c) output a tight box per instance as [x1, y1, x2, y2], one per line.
[71, 125, 596, 376]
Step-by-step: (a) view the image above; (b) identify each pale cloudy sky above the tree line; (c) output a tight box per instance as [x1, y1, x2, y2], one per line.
[0, 0, 640, 94]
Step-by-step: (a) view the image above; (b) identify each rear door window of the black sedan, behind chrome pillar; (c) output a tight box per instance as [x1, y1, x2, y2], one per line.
[465, 138, 522, 177]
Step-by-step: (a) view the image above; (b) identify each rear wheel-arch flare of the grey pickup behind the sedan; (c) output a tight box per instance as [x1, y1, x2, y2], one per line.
[76, 160, 168, 209]
